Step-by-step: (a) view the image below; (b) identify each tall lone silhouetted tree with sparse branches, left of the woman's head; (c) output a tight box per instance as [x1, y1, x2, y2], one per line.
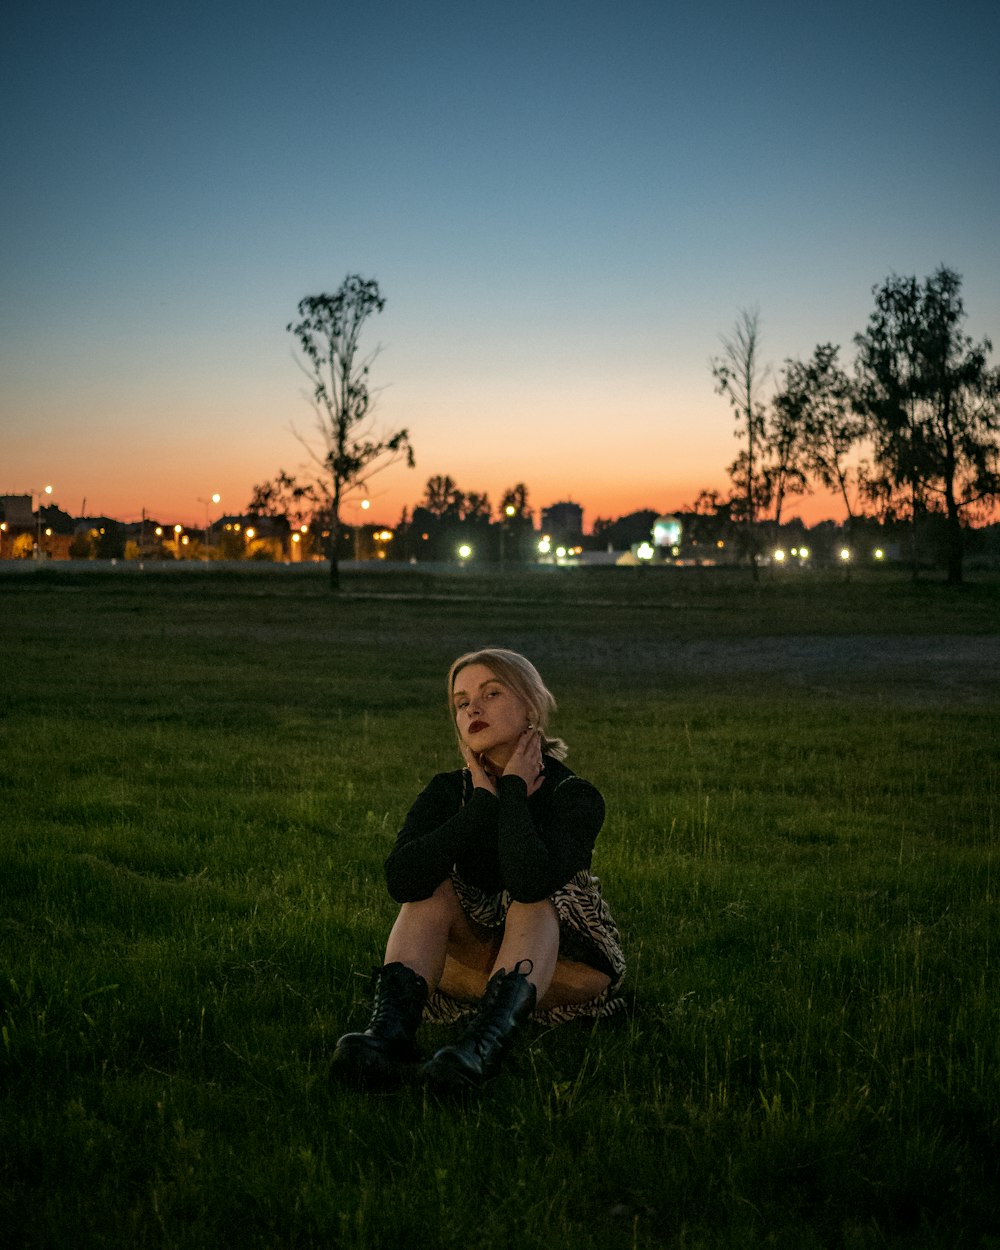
[286, 274, 414, 590]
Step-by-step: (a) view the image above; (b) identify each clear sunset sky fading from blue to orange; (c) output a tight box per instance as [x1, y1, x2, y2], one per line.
[0, 0, 1000, 528]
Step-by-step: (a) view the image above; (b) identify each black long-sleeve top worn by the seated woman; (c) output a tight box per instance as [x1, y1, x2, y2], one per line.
[385, 756, 604, 903]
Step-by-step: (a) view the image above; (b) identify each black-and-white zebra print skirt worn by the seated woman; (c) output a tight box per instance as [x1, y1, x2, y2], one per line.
[424, 871, 625, 1025]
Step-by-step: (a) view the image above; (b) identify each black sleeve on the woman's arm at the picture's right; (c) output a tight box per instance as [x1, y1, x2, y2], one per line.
[498, 776, 604, 903]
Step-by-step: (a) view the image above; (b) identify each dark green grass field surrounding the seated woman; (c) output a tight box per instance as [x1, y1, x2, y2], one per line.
[0, 569, 1000, 1250]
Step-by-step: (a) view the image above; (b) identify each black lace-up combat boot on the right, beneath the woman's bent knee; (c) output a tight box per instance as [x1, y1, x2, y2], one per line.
[421, 960, 535, 1090]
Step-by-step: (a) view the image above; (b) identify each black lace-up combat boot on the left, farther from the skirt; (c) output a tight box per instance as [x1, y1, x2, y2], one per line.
[330, 964, 428, 1084]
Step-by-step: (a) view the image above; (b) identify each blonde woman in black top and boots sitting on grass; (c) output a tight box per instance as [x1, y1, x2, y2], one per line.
[331, 649, 625, 1089]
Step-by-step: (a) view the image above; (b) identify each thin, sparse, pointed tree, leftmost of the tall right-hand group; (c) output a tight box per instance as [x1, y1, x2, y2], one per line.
[711, 309, 769, 581]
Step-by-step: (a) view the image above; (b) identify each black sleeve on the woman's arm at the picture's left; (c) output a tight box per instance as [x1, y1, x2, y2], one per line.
[385, 773, 498, 903]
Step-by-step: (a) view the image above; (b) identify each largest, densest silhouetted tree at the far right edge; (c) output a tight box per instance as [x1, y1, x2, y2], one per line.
[855, 266, 1000, 584]
